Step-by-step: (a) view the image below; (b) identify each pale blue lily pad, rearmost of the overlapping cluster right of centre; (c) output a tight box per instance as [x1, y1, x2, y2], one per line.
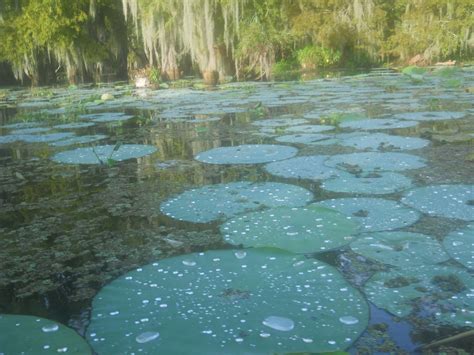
[339, 133, 430, 150]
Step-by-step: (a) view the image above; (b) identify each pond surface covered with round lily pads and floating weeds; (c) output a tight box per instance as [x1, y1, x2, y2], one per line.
[0, 67, 474, 355]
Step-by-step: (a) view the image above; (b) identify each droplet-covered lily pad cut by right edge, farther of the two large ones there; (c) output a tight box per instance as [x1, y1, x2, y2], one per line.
[401, 185, 474, 221]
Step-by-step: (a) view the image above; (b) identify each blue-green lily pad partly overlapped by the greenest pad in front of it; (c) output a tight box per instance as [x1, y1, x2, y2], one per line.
[160, 182, 313, 223]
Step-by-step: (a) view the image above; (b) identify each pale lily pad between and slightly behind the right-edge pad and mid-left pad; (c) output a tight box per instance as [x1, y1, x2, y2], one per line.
[321, 172, 412, 195]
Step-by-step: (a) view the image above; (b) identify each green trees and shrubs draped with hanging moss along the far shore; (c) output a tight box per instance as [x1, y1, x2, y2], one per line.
[0, 0, 474, 87]
